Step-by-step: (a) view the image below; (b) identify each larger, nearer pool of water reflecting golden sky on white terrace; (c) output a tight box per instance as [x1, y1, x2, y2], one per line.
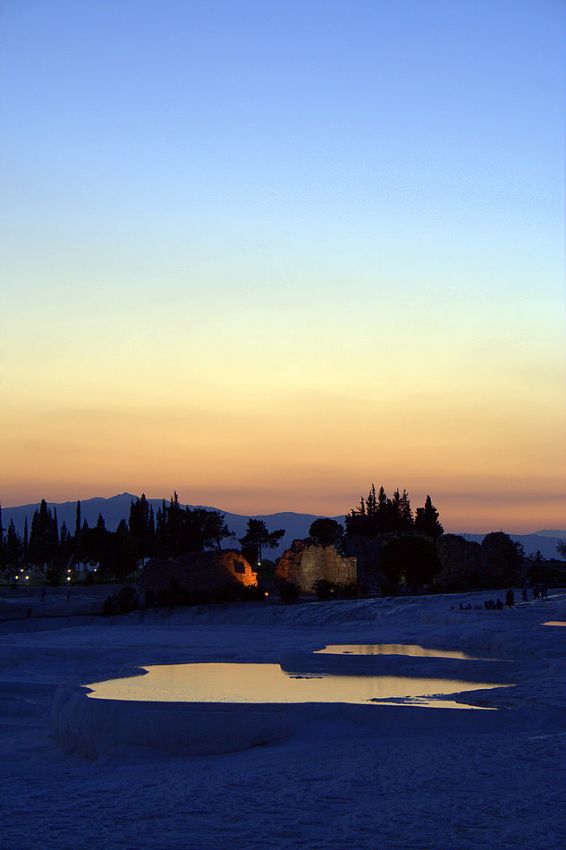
[86, 663, 509, 709]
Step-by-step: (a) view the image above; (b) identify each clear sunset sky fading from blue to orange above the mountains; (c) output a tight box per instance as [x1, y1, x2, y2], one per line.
[0, 0, 566, 531]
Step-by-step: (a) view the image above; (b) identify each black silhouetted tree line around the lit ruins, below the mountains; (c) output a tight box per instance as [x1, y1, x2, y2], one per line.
[0, 484, 566, 587]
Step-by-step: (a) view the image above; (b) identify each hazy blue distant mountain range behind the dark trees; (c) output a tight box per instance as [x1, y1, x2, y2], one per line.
[2, 493, 566, 558]
